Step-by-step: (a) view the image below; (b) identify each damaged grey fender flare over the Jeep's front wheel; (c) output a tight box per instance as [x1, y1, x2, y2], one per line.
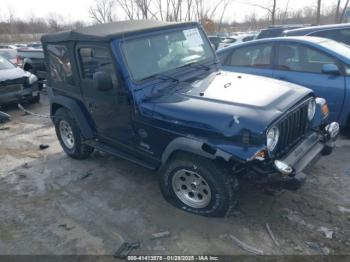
[162, 137, 232, 164]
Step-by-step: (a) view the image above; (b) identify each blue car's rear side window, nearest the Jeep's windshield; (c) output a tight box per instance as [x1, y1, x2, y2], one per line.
[227, 45, 272, 68]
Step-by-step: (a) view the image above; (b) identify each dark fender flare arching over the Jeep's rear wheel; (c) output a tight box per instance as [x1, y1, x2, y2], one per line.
[48, 88, 94, 139]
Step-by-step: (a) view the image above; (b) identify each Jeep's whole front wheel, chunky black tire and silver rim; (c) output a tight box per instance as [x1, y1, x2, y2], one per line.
[160, 153, 238, 217]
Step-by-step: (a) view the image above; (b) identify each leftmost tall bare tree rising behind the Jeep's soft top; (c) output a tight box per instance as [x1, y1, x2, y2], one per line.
[89, 0, 114, 24]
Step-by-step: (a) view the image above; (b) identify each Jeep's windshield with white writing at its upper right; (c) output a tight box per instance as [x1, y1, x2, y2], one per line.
[123, 28, 214, 81]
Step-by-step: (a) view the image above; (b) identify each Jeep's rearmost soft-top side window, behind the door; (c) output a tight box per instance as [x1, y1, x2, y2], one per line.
[47, 45, 74, 85]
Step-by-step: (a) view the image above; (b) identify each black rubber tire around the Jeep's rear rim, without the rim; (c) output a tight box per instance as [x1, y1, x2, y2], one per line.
[53, 108, 94, 160]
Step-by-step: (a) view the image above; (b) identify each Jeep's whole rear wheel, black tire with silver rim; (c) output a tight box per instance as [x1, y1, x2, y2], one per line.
[54, 108, 94, 159]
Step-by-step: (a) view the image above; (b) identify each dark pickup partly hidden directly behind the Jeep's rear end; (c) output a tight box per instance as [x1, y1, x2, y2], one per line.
[17, 49, 46, 89]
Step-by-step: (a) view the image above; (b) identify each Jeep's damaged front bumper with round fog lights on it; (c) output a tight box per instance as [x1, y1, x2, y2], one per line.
[256, 122, 339, 190]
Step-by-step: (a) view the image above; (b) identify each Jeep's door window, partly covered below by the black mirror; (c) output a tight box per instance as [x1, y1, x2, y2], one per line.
[79, 47, 116, 79]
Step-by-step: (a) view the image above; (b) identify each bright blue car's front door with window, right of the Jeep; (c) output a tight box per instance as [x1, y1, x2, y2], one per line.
[273, 43, 345, 121]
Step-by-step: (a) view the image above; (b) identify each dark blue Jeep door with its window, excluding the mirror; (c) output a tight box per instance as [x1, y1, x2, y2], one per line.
[77, 45, 134, 145]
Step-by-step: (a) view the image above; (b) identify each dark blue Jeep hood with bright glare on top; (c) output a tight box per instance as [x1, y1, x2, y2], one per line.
[142, 71, 312, 137]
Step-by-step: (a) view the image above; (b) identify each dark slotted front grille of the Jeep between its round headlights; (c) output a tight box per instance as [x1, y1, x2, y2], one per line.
[273, 99, 310, 156]
